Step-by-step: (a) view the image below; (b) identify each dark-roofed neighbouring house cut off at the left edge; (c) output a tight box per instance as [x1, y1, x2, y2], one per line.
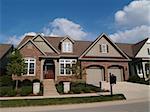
[0, 44, 13, 75]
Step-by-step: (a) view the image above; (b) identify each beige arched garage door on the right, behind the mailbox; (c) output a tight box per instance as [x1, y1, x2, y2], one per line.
[108, 67, 123, 82]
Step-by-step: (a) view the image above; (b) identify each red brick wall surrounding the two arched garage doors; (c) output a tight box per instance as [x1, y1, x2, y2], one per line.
[81, 61, 129, 81]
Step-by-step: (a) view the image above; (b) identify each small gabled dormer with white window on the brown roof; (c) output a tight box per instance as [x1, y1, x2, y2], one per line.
[60, 36, 74, 53]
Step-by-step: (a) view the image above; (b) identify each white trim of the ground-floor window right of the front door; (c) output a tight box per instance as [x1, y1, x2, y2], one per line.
[59, 59, 77, 76]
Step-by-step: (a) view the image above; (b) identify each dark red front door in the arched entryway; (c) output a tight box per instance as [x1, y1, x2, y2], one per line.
[45, 65, 55, 79]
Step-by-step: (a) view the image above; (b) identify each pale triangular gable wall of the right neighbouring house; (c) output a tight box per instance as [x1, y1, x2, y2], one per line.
[135, 39, 150, 57]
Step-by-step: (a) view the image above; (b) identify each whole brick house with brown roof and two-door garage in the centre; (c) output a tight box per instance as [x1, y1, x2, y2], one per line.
[14, 33, 130, 85]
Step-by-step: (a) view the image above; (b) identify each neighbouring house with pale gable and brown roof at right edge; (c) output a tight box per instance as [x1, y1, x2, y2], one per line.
[117, 38, 150, 79]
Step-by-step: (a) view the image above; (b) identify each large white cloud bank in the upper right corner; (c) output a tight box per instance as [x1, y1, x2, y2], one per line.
[110, 0, 150, 42]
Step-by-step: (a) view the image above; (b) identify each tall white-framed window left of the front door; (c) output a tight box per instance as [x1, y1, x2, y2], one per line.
[25, 58, 35, 76]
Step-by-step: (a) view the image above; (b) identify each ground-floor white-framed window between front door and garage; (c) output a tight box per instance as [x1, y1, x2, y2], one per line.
[59, 59, 76, 75]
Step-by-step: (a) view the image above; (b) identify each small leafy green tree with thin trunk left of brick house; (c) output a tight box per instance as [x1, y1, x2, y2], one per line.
[7, 49, 25, 90]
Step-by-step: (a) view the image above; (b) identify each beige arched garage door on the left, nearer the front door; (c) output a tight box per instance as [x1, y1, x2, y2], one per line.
[86, 67, 104, 86]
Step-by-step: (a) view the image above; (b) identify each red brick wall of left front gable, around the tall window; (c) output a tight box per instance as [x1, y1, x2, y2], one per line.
[13, 41, 42, 80]
